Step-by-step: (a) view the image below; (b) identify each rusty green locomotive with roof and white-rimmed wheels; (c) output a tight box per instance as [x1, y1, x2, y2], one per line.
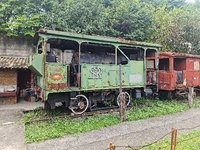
[30, 29, 160, 114]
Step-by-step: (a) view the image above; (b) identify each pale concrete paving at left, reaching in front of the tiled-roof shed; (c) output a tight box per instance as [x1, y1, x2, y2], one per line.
[0, 100, 43, 150]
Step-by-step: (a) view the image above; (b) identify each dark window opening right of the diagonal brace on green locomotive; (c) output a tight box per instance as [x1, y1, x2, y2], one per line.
[119, 46, 144, 61]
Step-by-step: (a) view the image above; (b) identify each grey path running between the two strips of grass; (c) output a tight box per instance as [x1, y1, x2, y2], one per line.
[27, 109, 200, 150]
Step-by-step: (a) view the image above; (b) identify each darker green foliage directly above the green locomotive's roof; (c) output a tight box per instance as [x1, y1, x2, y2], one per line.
[45, 0, 152, 40]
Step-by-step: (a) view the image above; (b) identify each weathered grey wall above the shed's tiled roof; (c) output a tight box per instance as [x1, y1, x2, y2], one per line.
[0, 34, 34, 56]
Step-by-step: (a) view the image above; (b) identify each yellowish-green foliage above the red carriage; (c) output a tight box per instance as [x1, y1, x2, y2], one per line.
[151, 3, 200, 53]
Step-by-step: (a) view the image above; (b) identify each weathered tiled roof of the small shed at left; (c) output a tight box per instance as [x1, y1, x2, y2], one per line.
[0, 56, 28, 68]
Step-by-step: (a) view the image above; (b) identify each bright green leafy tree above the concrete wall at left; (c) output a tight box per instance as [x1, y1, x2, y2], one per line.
[0, 0, 50, 36]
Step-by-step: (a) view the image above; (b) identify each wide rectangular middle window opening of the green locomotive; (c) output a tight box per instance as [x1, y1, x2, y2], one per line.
[80, 43, 115, 64]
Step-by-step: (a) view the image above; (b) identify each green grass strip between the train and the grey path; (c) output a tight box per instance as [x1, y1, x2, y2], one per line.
[23, 100, 200, 143]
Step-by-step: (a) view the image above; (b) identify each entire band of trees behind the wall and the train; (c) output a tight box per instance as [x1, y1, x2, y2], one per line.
[0, 0, 200, 53]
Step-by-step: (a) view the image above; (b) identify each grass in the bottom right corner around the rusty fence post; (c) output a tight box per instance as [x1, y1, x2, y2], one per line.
[142, 130, 200, 150]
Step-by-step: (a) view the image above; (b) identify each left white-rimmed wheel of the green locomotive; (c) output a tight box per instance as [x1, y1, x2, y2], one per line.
[69, 95, 89, 115]
